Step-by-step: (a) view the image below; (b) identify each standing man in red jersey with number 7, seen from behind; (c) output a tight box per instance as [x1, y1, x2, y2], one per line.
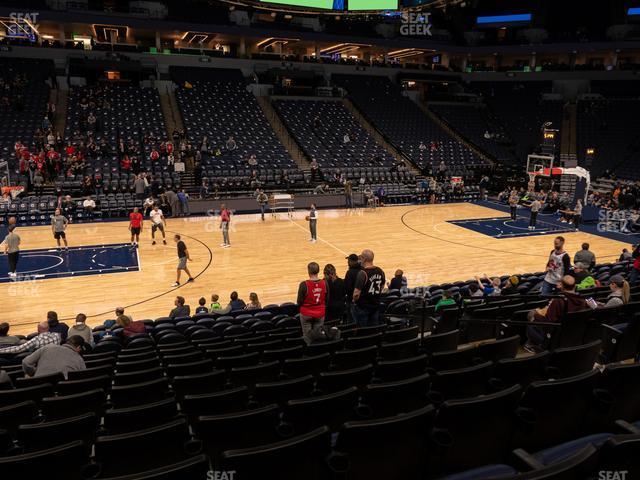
[298, 262, 329, 345]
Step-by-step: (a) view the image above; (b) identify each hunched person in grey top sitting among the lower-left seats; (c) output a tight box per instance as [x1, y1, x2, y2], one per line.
[22, 335, 87, 378]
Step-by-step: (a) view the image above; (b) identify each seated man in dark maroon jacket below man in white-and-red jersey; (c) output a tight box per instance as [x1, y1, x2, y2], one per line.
[524, 275, 589, 353]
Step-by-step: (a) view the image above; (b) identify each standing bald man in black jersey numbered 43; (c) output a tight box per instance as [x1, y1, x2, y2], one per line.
[351, 250, 385, 327]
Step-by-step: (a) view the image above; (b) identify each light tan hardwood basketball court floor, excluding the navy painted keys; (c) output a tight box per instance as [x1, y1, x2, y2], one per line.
[0, 204, 628, 334]
